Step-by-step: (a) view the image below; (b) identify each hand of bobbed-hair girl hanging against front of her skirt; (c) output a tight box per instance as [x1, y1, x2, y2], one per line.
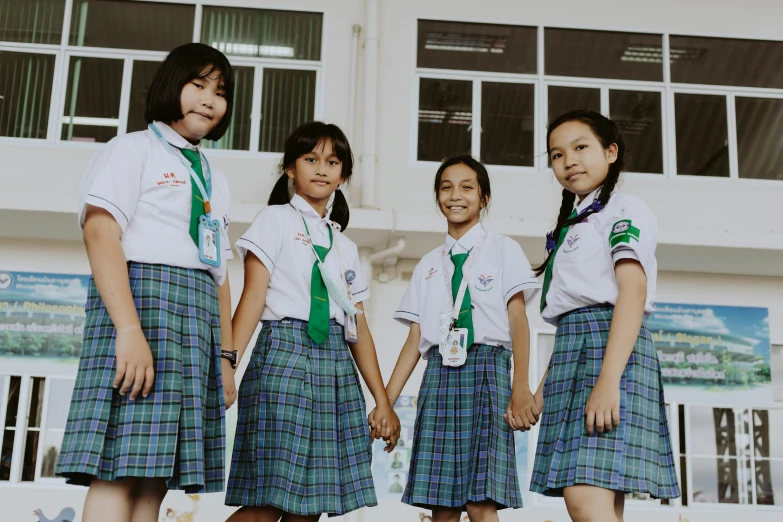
[114, 324, 155, 400]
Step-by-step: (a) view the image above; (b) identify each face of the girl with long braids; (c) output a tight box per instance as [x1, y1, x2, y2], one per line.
[549, 121, 618, 201]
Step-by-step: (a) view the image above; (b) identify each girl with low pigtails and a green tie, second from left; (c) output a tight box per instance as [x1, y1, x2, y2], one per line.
[226, 122, 400, 522]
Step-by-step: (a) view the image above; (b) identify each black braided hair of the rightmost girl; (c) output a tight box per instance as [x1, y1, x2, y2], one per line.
[535, 109, 625, 275]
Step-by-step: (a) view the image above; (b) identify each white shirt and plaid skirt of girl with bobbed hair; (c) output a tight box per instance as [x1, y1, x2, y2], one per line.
[57, 122, 233, 493]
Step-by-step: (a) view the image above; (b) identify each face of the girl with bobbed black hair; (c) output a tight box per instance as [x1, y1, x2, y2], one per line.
[170, 69, 228, 142]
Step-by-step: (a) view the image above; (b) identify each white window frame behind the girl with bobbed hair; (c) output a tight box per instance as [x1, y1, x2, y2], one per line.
[0, 0, 326, 156]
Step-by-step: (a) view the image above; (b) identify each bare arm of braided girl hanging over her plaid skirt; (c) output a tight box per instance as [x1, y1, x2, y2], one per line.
[585, 259, 647, 435]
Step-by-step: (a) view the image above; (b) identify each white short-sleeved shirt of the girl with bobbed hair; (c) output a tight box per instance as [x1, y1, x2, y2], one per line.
[79, 121, 234, 286]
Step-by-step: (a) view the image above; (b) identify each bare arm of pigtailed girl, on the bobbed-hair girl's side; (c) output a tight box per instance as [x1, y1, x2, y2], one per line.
[231, 250, 270, 365]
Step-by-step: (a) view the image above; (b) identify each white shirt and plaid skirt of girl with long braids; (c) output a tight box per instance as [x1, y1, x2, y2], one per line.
[530, 189, 680, 498]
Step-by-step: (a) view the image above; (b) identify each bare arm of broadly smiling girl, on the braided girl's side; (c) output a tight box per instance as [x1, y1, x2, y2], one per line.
[503, 292, 541, 430]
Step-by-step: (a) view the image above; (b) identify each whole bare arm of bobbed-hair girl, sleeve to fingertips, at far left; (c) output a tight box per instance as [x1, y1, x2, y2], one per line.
[84, 205, 155, 400]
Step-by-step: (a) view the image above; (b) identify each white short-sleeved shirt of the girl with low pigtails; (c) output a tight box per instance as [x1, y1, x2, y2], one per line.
[236, 195, 370, 325]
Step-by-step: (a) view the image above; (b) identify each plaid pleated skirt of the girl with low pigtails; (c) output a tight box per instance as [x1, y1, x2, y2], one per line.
[226, 319, 378, 516]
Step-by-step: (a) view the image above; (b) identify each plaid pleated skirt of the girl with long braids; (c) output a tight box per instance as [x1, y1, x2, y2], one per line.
[530, 305, 680, 498]
